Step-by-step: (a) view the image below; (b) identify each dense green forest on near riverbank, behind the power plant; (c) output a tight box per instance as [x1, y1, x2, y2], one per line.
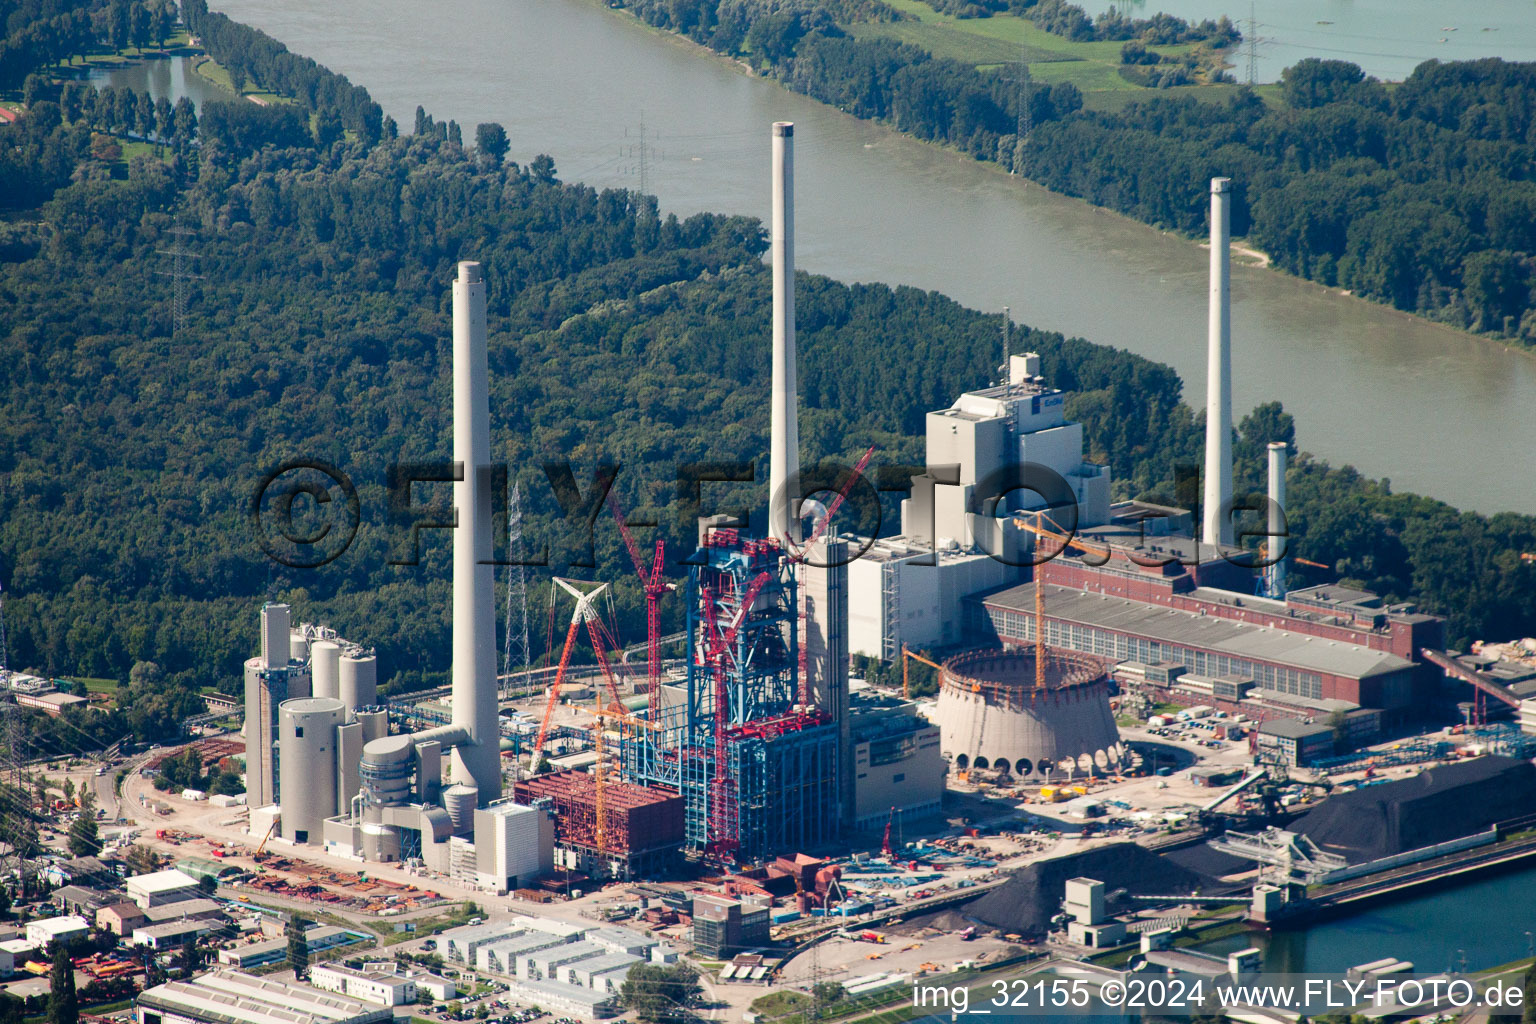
[0, 4, 1536, 749]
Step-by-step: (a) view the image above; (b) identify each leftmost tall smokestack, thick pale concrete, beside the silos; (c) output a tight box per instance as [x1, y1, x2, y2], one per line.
[452, 263, 501, 804]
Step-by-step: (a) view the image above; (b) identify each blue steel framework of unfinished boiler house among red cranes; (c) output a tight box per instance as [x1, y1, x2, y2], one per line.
[622, 530, 839, 861]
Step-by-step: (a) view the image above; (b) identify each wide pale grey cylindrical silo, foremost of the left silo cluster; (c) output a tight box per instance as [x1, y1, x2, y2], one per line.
[278, 697, 346, 846]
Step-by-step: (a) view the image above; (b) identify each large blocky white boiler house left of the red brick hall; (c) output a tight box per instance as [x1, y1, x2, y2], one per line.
[848, 353, 1109, 660]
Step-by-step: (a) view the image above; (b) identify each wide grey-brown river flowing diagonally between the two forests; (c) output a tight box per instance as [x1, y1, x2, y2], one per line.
[204, 0, 1536, 513]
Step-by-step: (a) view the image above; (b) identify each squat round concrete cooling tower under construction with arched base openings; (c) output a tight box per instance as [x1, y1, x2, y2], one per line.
[935, 649, 1124, 777]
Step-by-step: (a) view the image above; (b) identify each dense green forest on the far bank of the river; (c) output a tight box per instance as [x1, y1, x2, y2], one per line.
[602, 0, 1536, 344]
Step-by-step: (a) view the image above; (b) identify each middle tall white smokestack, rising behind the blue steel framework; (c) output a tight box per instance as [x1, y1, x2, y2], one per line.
[768, 121, 800, 540]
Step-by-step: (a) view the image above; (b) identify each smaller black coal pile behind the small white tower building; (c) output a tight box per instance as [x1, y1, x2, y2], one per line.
[963, 843, 1210, 936]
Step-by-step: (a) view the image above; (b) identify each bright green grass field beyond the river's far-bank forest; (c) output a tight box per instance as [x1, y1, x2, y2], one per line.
[849, 0, 1221, 100]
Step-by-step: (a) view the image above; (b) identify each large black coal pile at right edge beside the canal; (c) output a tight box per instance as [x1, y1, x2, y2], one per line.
[1290, 757, 1536, 864]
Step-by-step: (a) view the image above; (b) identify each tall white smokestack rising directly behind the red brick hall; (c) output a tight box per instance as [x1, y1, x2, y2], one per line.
[1200, 178, 1232, 545]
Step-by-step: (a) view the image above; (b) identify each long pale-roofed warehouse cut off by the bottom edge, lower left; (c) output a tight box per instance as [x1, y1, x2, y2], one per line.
[134, 970, 395, 1024]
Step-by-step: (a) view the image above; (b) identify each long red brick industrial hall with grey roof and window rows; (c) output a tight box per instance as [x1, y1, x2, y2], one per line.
[971, 505, 1445, 718]
